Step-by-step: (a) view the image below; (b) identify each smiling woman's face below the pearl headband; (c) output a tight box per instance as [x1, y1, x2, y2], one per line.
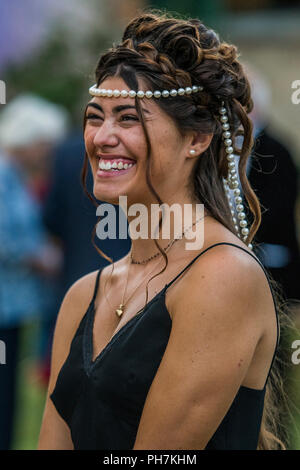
[84, 77, 195, 205]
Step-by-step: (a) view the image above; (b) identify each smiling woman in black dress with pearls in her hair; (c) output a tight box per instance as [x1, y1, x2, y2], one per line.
[39, 13, 292, 450]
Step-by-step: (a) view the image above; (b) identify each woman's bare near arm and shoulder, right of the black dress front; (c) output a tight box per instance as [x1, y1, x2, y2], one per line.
[134, 247, 271, 449]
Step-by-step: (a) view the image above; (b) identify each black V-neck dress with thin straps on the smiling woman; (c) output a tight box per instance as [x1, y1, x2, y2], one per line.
[50, 242, 279, 450]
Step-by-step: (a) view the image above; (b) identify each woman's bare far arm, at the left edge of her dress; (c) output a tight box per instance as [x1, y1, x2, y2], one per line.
[38, 271, 97, 450]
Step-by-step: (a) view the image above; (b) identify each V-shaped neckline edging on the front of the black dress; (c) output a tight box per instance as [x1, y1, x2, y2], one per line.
[83, 270, 169, 370]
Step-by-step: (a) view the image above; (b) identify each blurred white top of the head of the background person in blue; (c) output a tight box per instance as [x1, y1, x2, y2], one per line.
[0, 94, 69, 148]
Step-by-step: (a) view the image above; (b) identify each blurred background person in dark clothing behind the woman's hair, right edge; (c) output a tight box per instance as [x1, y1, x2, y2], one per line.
[246, 64, 300, 316]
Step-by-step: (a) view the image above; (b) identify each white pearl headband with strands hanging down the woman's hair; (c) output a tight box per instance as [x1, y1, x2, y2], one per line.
[89, 84, 253, 250]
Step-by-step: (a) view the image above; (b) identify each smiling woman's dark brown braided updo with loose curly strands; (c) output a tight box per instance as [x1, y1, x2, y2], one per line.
[82, 12, 294, 449]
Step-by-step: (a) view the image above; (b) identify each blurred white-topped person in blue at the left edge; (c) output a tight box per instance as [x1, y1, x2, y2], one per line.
[0, 94, 68, 449]
